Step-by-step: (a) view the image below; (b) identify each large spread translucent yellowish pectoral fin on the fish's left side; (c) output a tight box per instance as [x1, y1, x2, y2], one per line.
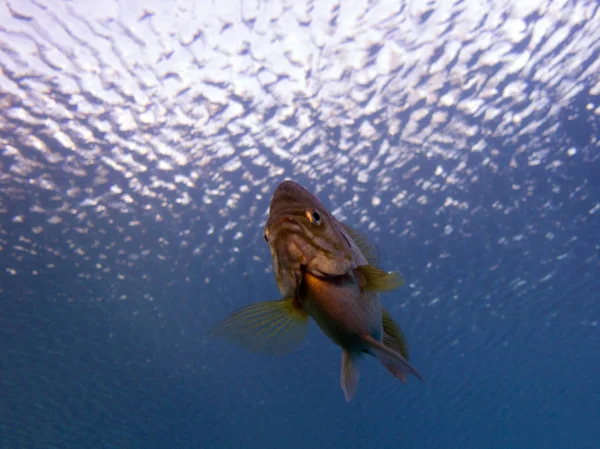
[212, 299, 308, 354]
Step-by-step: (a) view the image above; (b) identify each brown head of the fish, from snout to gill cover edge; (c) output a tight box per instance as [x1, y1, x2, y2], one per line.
[265, 181, 356, 298]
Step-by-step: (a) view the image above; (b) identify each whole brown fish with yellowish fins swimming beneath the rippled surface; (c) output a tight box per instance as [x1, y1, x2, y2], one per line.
[212, 180, 424, 402]
